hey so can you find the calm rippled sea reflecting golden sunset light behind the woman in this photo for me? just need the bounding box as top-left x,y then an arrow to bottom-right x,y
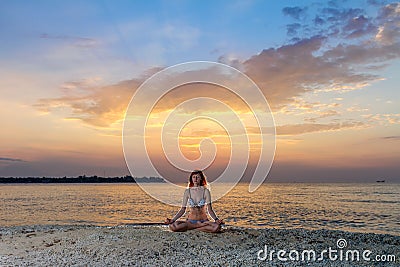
0,183 -> 400,235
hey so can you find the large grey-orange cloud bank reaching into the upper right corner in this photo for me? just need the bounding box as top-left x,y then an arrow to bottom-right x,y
243,4 -> 400,103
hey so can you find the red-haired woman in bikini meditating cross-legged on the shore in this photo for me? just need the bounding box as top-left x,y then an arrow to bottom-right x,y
165,170 -> 224,233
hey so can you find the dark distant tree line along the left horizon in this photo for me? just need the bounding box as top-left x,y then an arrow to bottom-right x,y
0,175 -> 165,184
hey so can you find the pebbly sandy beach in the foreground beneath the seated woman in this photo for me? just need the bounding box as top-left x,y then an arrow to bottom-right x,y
0,225 -> 400,266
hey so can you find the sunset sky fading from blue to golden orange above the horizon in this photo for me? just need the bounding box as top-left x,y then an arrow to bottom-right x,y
0,0 -> 400,182
